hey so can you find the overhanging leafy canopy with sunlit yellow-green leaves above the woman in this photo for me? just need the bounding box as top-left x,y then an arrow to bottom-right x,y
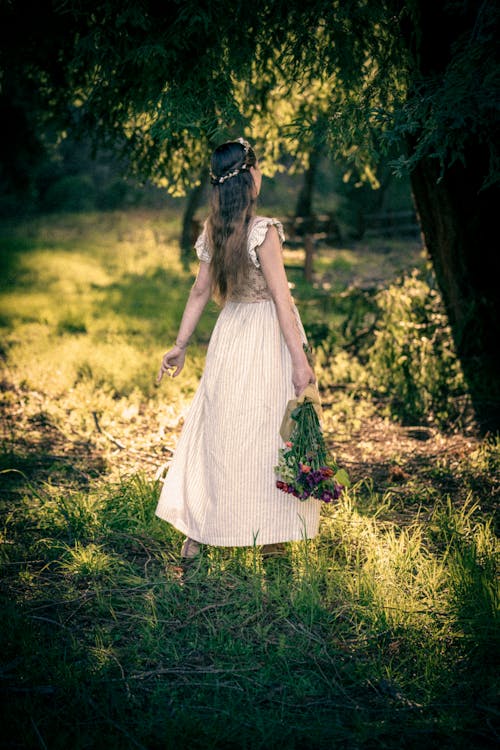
0,0 -> 498,191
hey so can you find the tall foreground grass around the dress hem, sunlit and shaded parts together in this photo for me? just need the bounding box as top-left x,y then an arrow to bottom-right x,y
1,476 -> 498,748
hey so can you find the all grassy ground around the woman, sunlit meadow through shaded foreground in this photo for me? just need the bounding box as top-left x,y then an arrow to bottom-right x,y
0,213 -> 500,750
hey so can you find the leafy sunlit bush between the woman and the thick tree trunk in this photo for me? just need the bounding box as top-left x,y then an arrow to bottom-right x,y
292,254 -> 471,429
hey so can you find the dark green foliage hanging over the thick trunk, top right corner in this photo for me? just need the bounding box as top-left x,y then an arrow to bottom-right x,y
386,0 -> 500,189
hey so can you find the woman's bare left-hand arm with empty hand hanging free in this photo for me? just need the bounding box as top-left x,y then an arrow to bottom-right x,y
156,261 -> 212,384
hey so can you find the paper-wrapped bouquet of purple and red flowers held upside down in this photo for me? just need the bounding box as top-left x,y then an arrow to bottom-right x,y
275,387 -> 349,503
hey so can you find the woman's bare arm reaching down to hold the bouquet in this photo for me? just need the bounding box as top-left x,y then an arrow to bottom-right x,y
258,226 -> 316,396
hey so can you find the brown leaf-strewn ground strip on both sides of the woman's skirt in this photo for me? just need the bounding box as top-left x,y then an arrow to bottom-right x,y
0,381 -> 500,523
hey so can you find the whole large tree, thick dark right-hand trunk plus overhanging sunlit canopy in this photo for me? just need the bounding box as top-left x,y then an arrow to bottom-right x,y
0,0 -> 500,429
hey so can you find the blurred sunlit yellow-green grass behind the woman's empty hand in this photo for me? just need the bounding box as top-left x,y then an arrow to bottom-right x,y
0,209 -> 214,406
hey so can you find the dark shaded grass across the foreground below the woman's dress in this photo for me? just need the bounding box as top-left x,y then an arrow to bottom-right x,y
0,536 -> 494,750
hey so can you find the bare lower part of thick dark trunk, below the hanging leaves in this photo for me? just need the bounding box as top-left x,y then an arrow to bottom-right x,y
411,144 -> 500,432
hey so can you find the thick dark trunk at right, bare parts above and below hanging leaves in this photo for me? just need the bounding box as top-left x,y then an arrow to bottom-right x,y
401,0 -> 500,432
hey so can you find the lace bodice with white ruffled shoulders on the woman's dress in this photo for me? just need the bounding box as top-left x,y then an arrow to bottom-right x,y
195,216 -> 285,302
